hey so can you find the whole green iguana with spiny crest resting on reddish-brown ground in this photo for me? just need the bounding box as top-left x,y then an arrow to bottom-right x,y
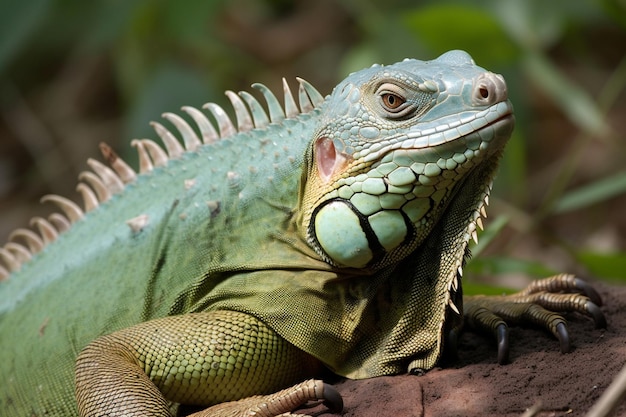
0,51 -> 604,416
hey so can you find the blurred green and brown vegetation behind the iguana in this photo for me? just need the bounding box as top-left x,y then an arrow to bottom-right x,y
0,0 -> 626,287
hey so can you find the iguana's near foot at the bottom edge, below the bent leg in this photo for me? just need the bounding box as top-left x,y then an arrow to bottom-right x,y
189,379 -> 343,417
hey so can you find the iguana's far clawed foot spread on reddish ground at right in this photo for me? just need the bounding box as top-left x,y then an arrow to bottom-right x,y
464,274 -> 606,364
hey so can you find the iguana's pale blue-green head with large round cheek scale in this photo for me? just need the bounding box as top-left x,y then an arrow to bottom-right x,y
300,51 -> 514,268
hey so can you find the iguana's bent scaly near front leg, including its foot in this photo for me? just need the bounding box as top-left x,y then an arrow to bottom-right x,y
76,311 -> 341,417
